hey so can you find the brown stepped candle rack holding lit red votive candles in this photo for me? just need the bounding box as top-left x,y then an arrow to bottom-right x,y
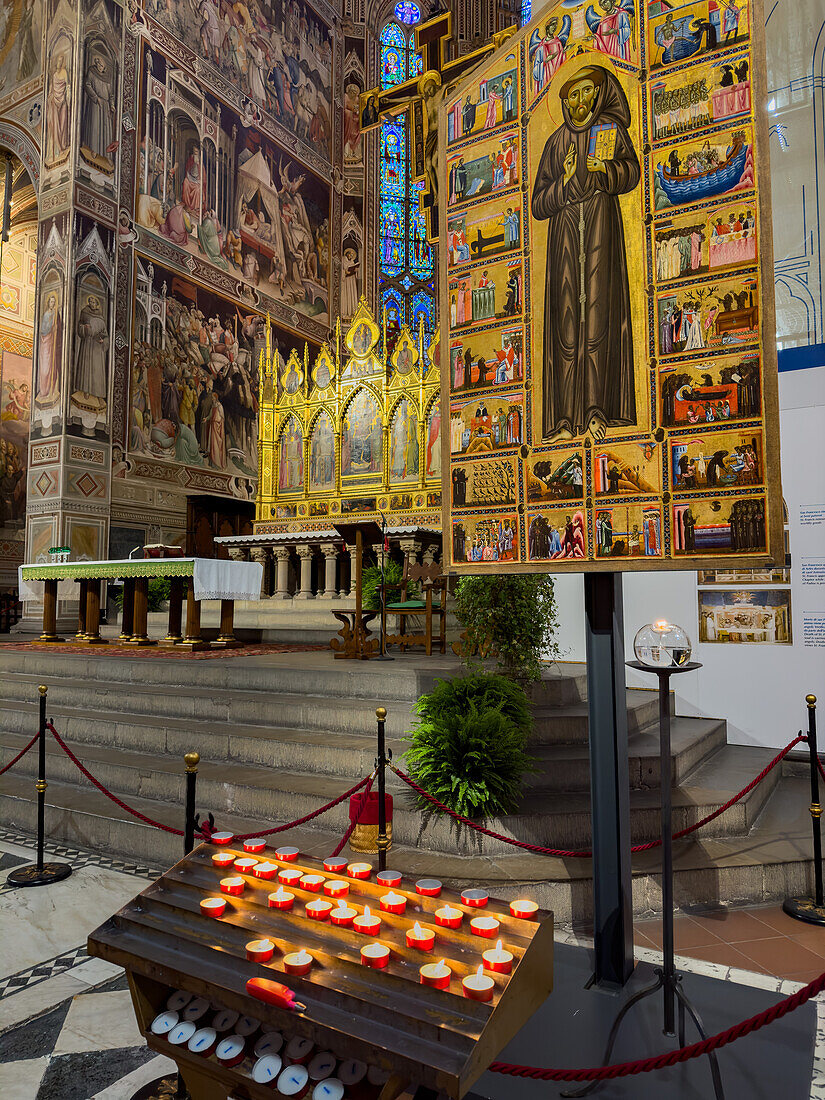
88,842 -> 553,1100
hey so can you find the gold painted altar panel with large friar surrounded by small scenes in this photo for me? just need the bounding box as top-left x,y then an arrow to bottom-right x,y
439,0 -> 782,572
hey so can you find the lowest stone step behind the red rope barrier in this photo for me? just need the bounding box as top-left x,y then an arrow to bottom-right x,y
0,772 -> 813,923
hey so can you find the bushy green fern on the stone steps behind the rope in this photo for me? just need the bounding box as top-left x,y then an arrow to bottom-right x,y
406,671 -> 534,817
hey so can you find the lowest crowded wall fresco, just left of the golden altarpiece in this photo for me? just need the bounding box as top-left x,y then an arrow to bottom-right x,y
129,260 -> 269,477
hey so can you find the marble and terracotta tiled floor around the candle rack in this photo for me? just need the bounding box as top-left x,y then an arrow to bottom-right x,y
0,828 -> 825,1100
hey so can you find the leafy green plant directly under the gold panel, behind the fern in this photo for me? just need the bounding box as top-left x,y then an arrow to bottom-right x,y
455,573 -> 558,683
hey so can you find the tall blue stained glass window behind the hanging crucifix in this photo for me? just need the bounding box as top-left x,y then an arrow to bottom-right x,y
378,19 -> 436,342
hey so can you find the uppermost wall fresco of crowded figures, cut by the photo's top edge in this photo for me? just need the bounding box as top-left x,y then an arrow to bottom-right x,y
152,0 -> 332,157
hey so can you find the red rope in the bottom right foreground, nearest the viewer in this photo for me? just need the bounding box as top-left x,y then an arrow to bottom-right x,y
490,972 -> 825,1081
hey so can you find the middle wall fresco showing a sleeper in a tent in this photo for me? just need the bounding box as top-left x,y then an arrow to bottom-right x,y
136,54 -> 330,322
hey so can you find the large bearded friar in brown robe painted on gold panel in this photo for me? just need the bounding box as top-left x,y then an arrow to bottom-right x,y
531,66 -> 640,439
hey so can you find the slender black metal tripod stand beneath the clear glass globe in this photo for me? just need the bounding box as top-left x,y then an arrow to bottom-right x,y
562,661 -> 725,1100
